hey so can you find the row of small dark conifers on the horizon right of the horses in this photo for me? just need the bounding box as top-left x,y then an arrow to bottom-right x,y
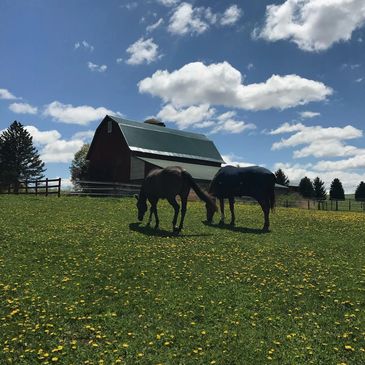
275,169 -> 365,201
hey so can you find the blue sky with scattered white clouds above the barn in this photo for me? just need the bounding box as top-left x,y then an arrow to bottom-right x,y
0,0 -> 365,193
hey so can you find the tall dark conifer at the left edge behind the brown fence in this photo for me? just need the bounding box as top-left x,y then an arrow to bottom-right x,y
0,121 -> 45,192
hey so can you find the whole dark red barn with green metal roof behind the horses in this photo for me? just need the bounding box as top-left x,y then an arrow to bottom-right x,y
87,115 -> 224,183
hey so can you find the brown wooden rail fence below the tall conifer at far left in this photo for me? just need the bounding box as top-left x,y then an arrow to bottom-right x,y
2,178 -> 61,197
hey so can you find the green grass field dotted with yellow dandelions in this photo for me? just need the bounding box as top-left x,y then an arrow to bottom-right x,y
0,195 -> 365,365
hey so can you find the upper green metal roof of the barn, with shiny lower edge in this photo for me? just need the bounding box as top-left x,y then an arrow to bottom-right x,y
108,116 -> 224,163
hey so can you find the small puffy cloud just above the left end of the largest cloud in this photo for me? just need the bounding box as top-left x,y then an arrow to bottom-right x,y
126,38 -> 160,65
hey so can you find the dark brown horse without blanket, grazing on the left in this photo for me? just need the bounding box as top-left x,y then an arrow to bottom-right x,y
136,166 -> 217,232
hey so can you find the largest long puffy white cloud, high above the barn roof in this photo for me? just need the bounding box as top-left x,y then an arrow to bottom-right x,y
138,62 -> 332,110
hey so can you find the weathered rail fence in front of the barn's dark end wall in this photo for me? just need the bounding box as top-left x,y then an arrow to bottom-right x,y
69,181 -> 141,197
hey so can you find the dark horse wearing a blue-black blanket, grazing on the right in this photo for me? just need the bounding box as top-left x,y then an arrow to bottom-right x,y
206,166 -> 276,231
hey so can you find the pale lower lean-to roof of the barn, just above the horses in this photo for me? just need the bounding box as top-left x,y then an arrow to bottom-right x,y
138,157 -> 220,180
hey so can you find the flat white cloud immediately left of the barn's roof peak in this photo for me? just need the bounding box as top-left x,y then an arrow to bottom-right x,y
43,101 -> 121,125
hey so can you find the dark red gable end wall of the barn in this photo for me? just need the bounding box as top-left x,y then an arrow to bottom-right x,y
89,118 -> 130,182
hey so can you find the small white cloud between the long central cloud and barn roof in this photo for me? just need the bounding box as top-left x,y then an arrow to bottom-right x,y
157,104 -> 215,129
